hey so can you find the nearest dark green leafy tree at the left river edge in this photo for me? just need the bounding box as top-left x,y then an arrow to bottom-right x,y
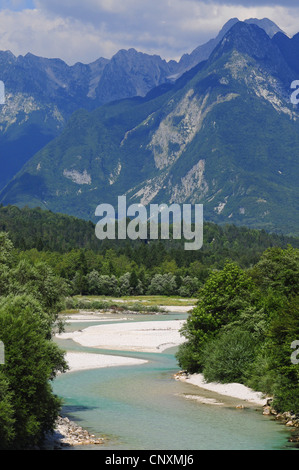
0,295 -> 67,448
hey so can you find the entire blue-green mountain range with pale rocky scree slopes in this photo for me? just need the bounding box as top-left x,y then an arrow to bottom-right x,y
0,19 -> 299,235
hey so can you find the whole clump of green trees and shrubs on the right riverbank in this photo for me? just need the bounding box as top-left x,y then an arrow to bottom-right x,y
177,247 -> 299,414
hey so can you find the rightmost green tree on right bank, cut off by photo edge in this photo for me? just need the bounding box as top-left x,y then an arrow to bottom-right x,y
248,246 -> 299,412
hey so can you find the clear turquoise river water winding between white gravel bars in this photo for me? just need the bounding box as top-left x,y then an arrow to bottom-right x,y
53,315 -> 294,450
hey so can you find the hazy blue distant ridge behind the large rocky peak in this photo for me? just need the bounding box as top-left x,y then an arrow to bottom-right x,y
0,18 -> 280,190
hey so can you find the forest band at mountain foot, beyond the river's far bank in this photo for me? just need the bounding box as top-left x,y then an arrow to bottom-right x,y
0,206 -> 299,296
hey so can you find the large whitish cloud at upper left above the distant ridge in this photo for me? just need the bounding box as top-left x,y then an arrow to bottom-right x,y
0,10 -> 119,63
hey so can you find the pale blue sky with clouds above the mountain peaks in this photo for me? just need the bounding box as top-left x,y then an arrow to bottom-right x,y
0,0 -> 299,64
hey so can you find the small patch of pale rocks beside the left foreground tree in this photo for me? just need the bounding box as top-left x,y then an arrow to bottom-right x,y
39,416 -> 105,450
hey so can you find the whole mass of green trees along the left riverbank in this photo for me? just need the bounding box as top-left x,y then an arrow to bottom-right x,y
0,233 -> 67,449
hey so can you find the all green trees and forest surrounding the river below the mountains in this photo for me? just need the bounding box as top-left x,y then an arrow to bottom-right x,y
0,207 -> 299,449
